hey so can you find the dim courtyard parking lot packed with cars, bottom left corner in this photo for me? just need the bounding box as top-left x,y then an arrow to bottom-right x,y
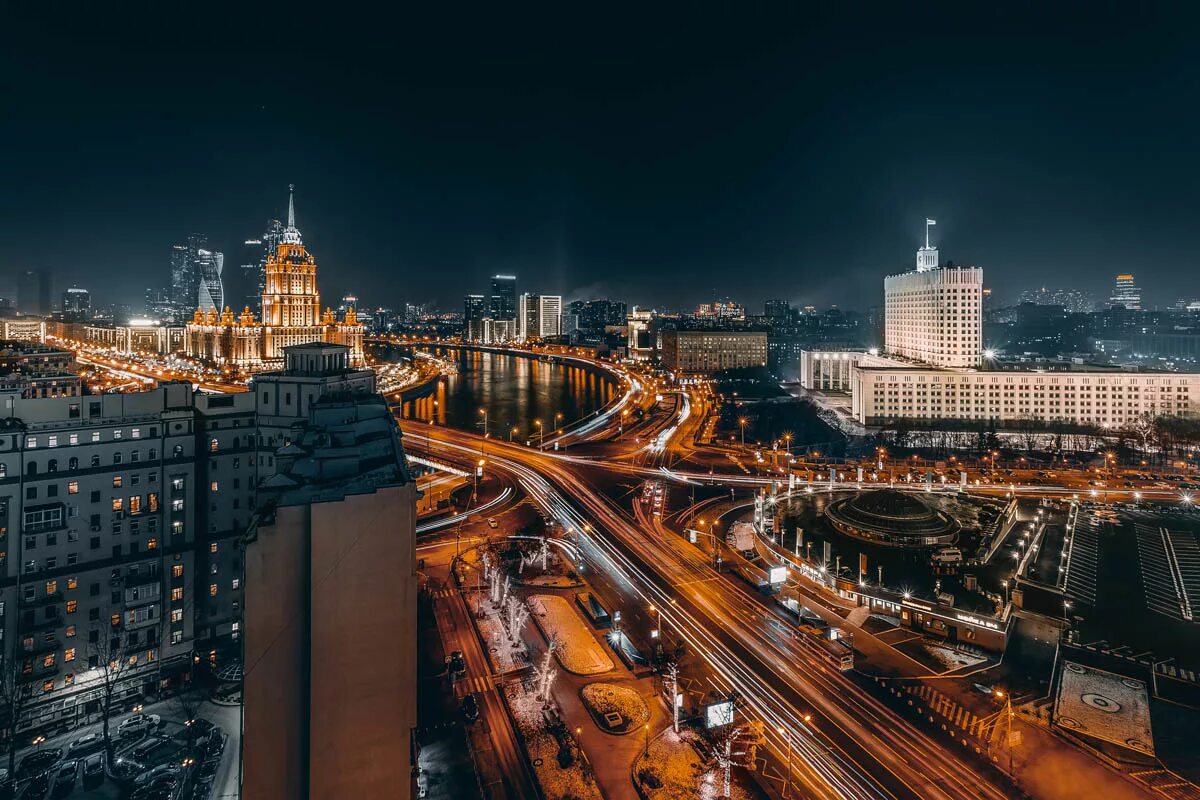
0,700 -> 240,800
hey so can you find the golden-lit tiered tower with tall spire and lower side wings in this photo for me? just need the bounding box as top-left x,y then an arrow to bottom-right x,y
186,193 -> 364,367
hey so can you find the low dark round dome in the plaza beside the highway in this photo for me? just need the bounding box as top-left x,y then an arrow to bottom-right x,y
824,489 -> 960,547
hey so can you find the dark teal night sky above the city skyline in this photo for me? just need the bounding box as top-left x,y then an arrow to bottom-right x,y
0,2 -> 1200,311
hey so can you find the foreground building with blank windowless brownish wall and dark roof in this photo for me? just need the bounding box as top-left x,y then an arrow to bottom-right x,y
242,345 -> 416,800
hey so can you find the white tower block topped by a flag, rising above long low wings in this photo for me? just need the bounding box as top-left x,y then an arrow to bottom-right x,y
883,223 -> 983,367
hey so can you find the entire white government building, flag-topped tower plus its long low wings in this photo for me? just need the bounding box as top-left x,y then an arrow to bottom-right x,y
800,221 -> 1200,428
